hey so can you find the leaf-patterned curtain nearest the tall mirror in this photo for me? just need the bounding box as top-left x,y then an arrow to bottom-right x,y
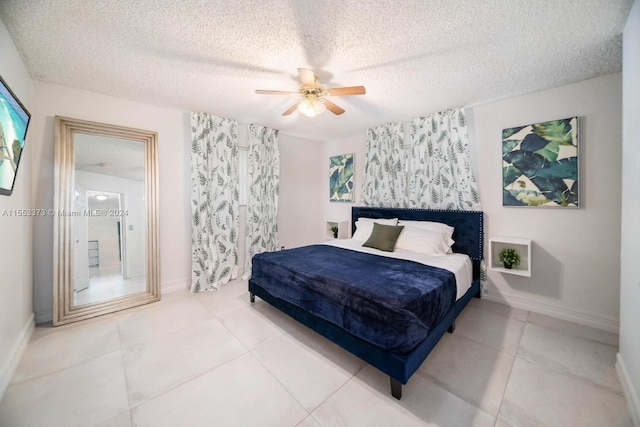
191,113 -> 239,292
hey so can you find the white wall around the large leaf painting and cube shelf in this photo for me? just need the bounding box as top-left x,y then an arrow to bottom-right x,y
471,73 -> 622,332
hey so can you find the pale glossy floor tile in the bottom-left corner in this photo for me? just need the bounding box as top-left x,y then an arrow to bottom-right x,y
0,351 -> 129,427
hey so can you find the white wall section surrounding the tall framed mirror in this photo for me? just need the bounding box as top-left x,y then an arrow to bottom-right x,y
30,82 -> 191,322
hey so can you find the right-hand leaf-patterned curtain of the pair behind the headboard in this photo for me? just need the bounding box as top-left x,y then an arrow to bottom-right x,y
408,108 -> 481,211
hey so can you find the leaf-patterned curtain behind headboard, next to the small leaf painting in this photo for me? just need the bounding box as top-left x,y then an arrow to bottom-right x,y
362,122 -> 407,208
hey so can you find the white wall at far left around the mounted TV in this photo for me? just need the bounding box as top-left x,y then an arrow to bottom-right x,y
0,21 -> 35,399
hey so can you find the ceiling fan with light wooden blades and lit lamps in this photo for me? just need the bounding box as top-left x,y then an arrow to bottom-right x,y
256,68 -> 366,117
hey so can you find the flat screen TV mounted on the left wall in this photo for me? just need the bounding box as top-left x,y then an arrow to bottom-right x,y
0,76 -> 31,196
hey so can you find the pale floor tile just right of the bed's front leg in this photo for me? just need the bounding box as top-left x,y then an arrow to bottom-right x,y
420,333 -> 514,416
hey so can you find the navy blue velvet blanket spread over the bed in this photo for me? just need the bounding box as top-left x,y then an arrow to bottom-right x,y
251,245 -> 456,354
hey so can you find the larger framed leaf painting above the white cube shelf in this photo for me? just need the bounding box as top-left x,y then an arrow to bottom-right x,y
502,117 -> 580,207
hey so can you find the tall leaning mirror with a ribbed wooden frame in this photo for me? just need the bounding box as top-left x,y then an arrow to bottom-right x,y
53,117 -> 160,326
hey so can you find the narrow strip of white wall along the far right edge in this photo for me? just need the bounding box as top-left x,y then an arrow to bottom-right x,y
618,0 -> 640,425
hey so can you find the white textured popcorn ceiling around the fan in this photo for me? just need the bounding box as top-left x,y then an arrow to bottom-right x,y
0,0 -> 633,141
